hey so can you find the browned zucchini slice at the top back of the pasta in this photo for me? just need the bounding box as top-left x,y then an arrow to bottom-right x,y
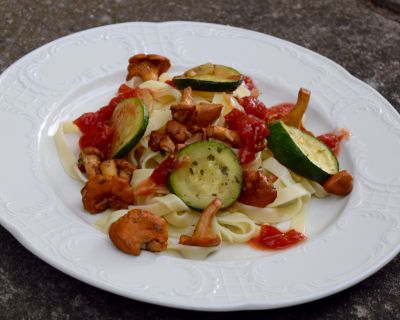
172,63 -> 243,92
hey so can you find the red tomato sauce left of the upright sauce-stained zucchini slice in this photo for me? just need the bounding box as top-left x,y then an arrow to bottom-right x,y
74,84 -> 137,158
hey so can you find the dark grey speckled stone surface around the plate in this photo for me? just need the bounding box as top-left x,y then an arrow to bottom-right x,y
0,0 -> 400,320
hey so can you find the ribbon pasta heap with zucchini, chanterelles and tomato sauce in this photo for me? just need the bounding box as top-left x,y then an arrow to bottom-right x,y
55,54 -> 353,259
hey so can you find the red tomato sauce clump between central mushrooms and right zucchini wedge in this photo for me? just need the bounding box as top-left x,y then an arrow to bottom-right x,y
225,109 -> 269,164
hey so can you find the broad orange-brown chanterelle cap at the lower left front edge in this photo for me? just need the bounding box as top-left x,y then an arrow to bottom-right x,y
109,209 -> 168,256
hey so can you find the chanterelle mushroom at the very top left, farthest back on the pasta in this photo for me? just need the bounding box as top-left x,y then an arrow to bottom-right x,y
126,53 -> 171,81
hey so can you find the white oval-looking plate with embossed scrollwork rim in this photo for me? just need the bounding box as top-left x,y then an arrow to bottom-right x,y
0,22 -> 400,310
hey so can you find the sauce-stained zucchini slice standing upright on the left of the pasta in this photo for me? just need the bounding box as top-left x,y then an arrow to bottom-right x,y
111,98 -> 149,158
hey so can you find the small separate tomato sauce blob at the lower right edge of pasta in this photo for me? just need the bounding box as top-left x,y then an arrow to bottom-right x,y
248,224 -> 307,250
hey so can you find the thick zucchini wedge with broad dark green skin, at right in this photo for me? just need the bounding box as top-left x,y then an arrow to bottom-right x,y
267,121 -> 339,182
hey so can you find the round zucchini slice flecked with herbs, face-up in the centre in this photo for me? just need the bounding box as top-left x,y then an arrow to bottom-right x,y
168,140 -> 243,210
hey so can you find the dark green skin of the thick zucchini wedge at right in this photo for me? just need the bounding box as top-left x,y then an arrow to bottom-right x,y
267,121 -> 339,182
